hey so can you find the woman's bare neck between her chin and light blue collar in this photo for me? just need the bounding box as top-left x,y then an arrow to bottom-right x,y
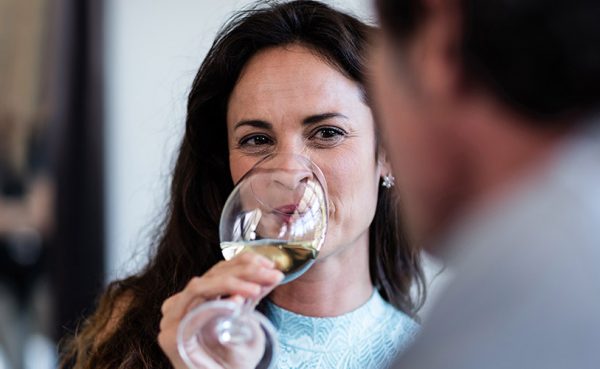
270,232 -> 373,317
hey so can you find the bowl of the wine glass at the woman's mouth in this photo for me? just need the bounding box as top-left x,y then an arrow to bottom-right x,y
219,154 -> 328,283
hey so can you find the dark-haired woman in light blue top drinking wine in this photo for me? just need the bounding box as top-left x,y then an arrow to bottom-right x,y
64,1 -> 424,368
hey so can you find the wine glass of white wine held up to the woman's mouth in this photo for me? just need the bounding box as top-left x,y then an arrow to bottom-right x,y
177,153 -> 328,369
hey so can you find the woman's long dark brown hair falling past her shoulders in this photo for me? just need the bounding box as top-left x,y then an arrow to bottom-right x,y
63,1 -> 425,368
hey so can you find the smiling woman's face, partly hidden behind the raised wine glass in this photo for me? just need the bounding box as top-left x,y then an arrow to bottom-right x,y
227,45 -> 387,258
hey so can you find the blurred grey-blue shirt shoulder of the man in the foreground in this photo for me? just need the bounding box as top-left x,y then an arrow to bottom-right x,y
396,127 -> 600,369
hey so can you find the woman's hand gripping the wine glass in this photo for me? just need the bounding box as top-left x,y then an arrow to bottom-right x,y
158,252 -> 283,369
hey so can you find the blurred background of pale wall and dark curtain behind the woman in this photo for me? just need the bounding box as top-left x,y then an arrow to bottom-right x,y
0,0 -> 384,369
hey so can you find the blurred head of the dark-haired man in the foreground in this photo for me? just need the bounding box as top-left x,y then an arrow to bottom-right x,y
373,0 -> 600,247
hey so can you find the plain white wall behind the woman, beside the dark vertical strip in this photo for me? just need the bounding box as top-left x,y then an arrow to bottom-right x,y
105,0 -> 372,280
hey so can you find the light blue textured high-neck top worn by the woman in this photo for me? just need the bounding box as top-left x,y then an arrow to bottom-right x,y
266,292 -> 419,369
